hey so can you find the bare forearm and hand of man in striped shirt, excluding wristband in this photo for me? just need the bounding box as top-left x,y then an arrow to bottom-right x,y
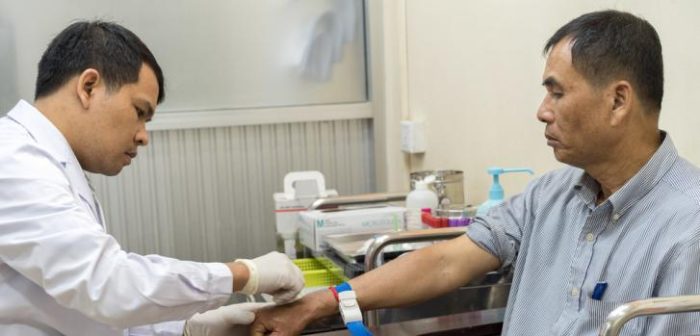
252,235 -> 500,335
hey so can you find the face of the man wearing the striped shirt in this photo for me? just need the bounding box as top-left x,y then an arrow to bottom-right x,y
537,39 -> 610,169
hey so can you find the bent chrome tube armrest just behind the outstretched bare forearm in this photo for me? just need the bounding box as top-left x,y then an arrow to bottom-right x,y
365,227 -> 466,327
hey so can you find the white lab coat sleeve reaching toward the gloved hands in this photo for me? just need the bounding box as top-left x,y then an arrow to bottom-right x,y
0,145 -> 232,329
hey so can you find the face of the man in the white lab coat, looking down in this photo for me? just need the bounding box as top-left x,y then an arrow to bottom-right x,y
78,65 -> 159,175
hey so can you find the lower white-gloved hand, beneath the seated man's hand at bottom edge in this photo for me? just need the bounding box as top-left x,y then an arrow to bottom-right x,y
184,302 -> 274,336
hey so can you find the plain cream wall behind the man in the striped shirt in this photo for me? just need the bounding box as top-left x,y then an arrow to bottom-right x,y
380,0 -> 700,204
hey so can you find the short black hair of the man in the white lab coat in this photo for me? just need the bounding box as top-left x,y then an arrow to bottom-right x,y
34,21 -> 165,103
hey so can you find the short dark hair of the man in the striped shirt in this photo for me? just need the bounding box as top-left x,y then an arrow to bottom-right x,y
544,10 -> 664,111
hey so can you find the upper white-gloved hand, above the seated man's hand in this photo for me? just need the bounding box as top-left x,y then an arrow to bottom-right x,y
236,252 -> 304,303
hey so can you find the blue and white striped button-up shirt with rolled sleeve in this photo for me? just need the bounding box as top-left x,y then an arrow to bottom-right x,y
468,134 -> 700,336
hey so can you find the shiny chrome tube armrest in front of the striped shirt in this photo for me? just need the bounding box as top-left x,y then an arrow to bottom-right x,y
598,295 -> 700,336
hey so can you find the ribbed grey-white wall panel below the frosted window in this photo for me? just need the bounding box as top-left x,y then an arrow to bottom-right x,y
91,119 -> 374,261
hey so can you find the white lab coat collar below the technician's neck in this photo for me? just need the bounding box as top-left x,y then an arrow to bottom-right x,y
7,100 -> 104,224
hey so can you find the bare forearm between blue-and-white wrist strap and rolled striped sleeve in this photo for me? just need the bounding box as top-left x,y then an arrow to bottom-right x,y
350,236 -> 499,310
